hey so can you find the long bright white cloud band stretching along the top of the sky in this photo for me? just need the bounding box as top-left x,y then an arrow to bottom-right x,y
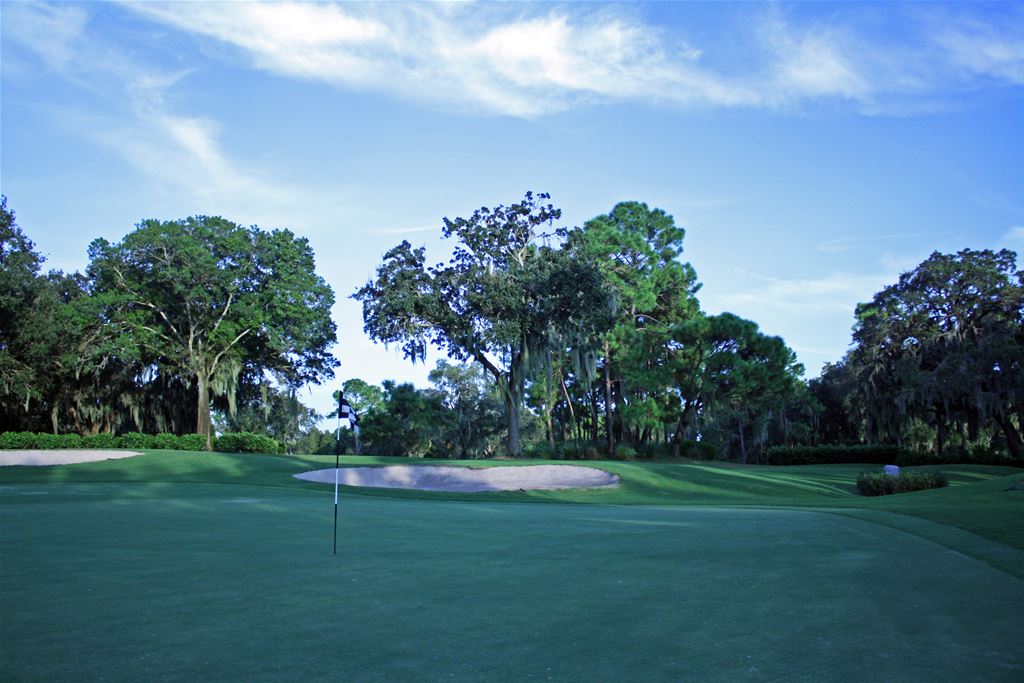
125,2 -> 1024,117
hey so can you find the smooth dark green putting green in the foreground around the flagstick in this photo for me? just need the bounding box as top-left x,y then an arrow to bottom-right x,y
0,482 -> 1024,681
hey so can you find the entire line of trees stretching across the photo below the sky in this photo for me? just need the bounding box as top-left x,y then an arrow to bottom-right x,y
0,193 -> 1024,462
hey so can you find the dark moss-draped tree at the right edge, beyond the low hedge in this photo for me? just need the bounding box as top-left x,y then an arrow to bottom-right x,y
849,249 -> 1024,458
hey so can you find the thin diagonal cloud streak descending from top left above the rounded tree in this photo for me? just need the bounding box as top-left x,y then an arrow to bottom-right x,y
4,3 -> 301,225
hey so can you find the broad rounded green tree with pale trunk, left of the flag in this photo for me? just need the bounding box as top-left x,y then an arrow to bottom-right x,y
88,216 -> 337,443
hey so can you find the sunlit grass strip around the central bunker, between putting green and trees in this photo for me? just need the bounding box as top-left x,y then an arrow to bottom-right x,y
0,451 -> 1024,552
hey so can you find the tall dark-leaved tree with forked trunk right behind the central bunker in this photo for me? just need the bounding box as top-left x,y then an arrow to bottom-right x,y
353,193 -> 607,456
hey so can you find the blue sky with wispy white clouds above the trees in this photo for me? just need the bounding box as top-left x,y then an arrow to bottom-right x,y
0,2 -> 1024,421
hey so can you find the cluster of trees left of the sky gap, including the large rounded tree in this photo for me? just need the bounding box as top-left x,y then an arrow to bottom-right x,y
0,198 -> 337,442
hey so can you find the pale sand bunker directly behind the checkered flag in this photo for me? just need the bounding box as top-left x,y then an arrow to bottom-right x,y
292,465 -> 618,493
